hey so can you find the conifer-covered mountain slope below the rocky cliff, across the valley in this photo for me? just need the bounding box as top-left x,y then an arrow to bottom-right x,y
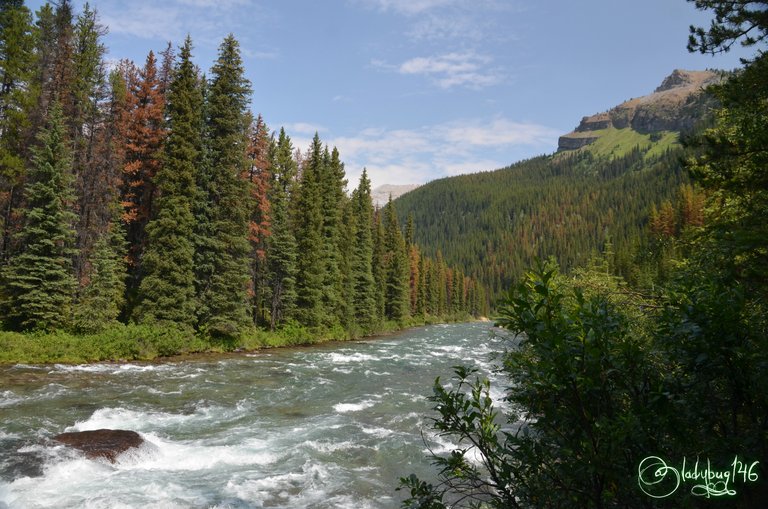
396,97 -> 707,302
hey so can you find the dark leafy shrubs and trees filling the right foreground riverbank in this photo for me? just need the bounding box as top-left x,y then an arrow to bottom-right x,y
401,0 -> 768,509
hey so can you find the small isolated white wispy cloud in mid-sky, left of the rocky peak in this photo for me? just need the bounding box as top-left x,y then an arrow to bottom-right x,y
378,51 -> 503,89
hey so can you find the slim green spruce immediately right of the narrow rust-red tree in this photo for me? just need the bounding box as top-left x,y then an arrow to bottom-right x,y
266,129 -> 297,330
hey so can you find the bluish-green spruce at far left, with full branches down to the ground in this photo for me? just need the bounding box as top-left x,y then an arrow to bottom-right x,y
3,103 -> 76,329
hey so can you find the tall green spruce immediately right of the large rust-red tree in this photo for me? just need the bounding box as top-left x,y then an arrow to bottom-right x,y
134,38 -> 203,327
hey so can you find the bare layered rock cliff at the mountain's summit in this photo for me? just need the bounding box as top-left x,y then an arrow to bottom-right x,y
558,69 -> 722,151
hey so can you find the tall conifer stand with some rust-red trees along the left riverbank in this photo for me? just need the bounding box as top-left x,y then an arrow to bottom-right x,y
0,0 -> 486,358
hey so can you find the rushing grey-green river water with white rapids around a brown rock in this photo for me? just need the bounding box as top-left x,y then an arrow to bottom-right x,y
0,323 -> 502,509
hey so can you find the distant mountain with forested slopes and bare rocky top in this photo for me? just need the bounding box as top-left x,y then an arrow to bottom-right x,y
396,70 -> 721,304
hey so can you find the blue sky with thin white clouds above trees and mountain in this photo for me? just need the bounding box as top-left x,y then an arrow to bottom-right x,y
27,0 -> 751,188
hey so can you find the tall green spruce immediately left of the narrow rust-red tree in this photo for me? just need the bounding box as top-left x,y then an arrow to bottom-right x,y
200,34 -> 251,336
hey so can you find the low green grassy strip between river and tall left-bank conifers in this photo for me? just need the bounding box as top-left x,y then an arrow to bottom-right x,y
0,315 -> 470,364
